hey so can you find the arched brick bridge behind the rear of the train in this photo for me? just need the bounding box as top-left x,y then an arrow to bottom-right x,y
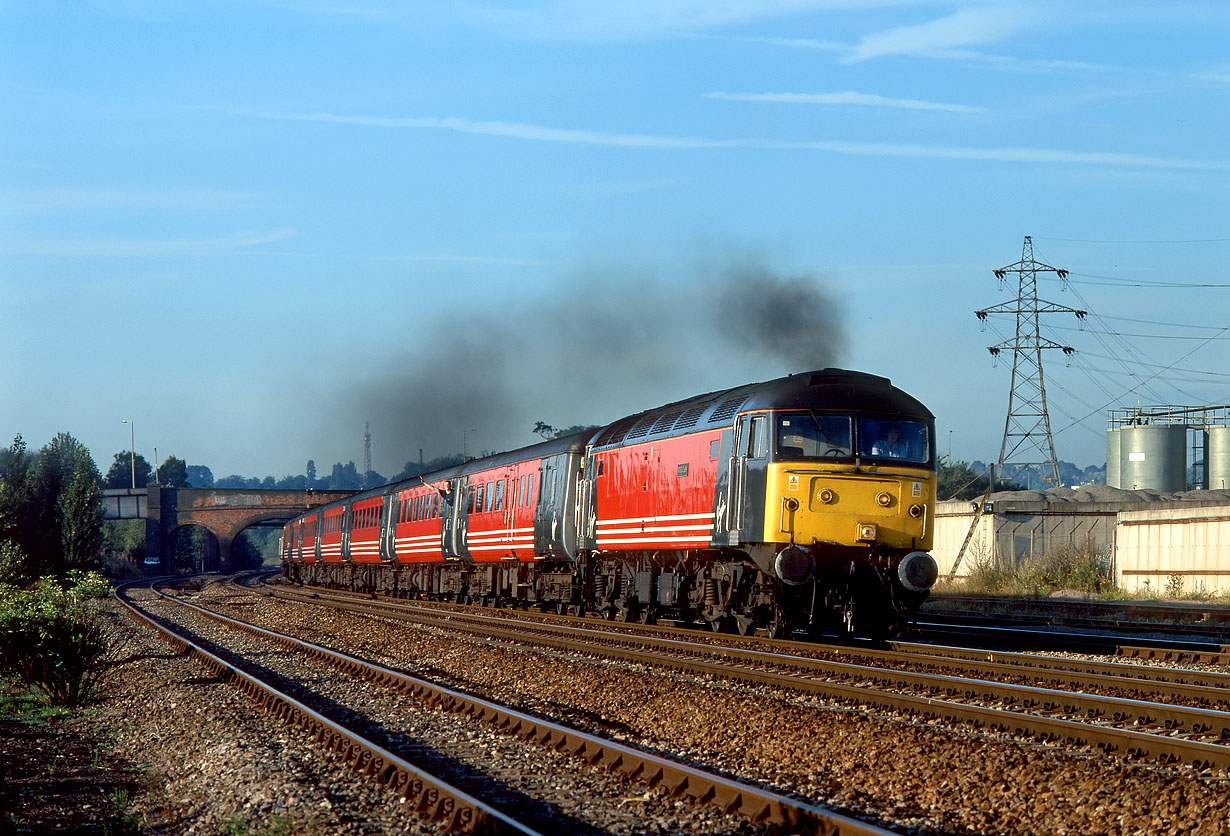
144,487 -> 353,572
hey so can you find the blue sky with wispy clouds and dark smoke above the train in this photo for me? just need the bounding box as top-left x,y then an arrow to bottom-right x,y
0,0 -> 1230,477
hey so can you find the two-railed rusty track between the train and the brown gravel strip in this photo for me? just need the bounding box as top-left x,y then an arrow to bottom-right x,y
269,589 -> 1230,768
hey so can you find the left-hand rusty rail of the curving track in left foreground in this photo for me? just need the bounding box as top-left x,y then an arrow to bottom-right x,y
114,582 -> 541,836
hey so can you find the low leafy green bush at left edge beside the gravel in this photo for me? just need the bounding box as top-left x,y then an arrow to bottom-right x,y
0,572 -> 111,706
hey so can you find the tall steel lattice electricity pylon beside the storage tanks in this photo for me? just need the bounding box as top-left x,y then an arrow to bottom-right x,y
974,235 -> 1086,487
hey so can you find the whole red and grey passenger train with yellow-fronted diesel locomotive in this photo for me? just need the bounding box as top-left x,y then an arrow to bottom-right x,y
280,369 -> 937,637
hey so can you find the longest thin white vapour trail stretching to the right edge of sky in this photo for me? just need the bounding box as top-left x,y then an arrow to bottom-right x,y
257,113 -> 1230,171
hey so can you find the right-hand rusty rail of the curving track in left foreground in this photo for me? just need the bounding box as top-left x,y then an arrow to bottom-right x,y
158,580 -> 893,836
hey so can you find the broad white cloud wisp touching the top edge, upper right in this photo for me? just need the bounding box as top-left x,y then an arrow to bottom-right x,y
849,5 -> 1030,61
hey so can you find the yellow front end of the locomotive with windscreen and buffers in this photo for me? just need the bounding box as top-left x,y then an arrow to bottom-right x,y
742,409 -> 937,633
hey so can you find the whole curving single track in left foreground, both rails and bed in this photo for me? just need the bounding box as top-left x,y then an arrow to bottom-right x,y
115,577 -> 892,835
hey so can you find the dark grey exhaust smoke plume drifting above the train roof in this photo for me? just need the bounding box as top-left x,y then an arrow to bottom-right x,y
320,262 -> 846,477
